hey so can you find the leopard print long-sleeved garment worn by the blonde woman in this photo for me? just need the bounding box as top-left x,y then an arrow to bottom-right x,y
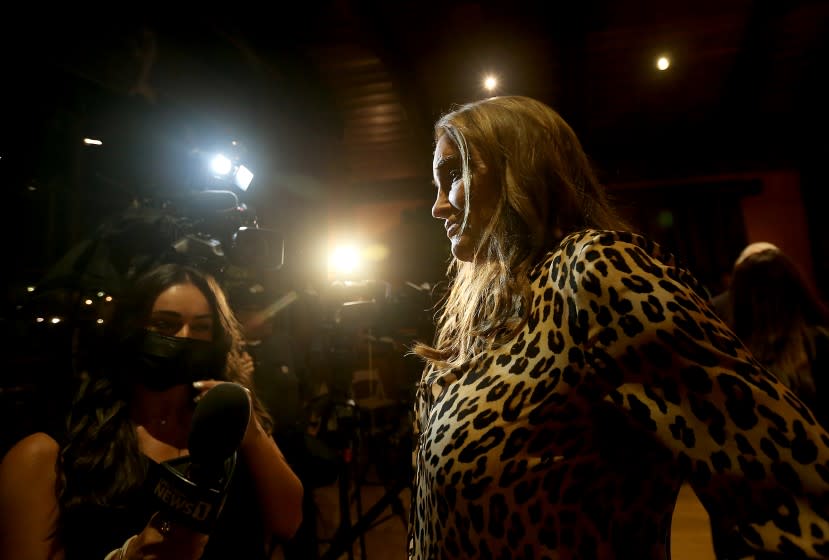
409,230 -> 829,560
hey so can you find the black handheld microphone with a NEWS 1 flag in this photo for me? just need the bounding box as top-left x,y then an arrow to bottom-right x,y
149,383 -> 251,534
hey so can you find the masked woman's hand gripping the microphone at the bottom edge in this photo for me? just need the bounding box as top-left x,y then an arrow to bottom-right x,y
121,512 -> 208,560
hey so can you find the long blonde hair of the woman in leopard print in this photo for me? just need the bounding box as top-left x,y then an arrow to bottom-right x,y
414,96 -> 627,368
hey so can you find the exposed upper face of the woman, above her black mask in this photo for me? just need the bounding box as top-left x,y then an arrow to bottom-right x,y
147,284 -> 214,341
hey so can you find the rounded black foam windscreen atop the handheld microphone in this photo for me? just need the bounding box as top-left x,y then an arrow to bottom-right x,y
187,383 -> 251,466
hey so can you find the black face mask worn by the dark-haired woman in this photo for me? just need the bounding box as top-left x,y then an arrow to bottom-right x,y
124,330 -> 225,391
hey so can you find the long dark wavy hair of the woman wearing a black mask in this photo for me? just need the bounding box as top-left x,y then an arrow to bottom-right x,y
58,264 -> 272,530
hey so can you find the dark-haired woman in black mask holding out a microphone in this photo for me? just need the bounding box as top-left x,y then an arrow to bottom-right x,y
0,264 -> 303,560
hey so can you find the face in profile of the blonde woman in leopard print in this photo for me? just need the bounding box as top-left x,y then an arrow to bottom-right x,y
432,134 -> 498,262
